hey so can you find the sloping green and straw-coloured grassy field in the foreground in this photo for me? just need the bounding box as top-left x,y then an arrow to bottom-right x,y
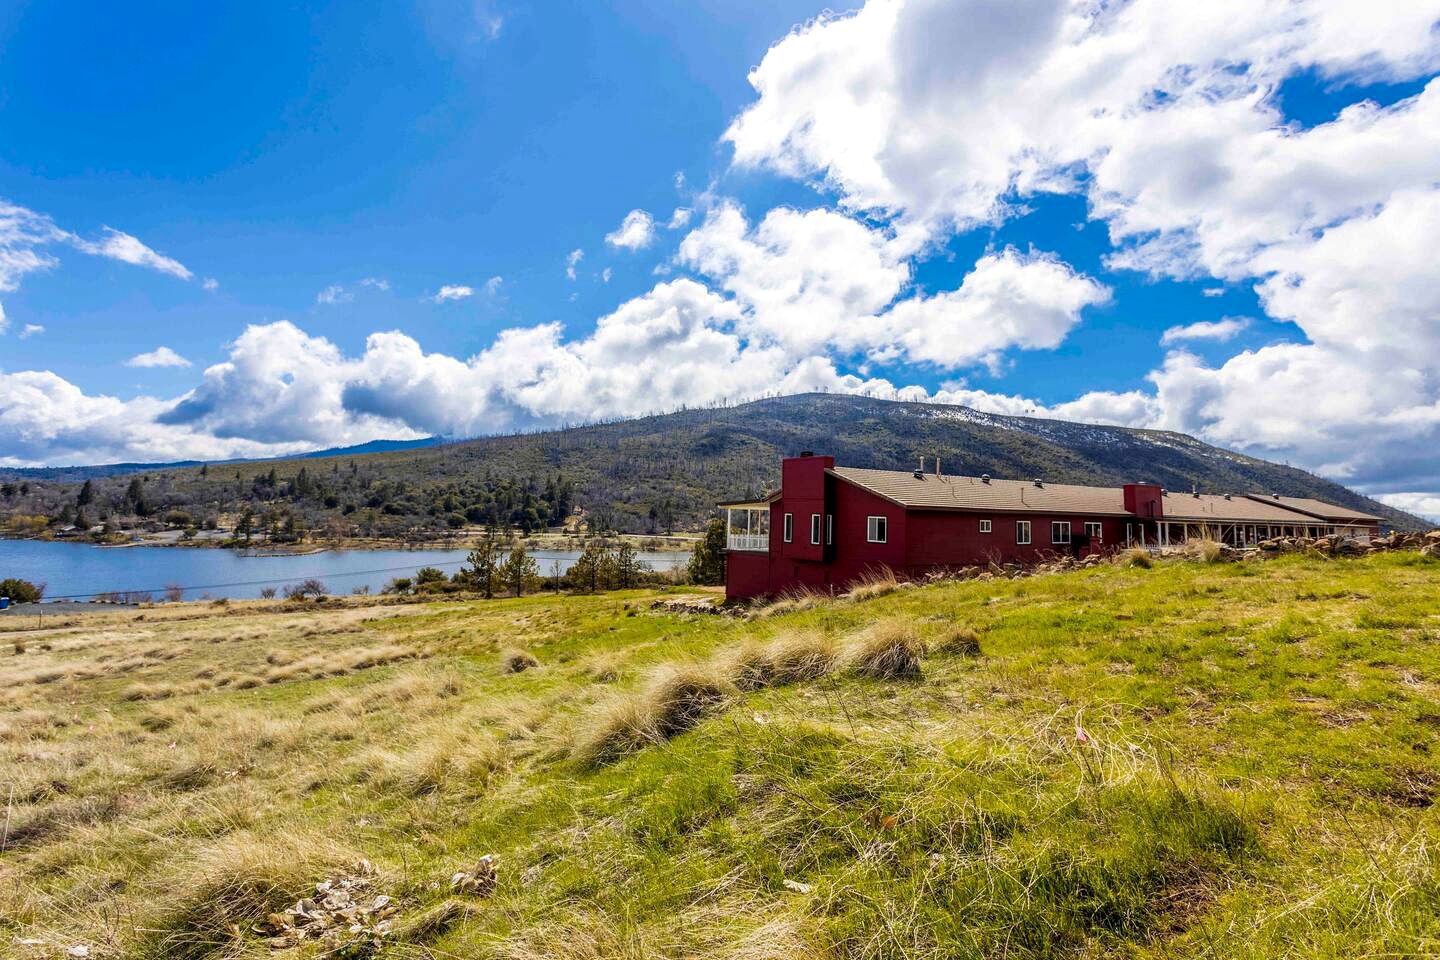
0,553 -> 1440,960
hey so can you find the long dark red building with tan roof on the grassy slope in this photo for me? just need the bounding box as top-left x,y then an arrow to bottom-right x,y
720,453 -> 1380,599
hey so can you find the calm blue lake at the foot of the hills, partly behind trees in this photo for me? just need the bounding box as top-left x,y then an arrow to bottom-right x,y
0,540 -> 690,600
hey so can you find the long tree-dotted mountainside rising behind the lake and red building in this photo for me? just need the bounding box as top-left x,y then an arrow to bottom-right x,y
0,394 -> 1421,540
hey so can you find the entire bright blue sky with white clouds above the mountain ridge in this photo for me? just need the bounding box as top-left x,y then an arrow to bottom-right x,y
0,0 -> 1440,511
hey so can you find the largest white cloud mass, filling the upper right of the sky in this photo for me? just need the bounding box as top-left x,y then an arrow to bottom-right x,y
726,0 -> 1440,489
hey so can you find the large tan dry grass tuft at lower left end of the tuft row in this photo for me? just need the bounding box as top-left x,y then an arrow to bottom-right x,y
570,664 -> 736,767
